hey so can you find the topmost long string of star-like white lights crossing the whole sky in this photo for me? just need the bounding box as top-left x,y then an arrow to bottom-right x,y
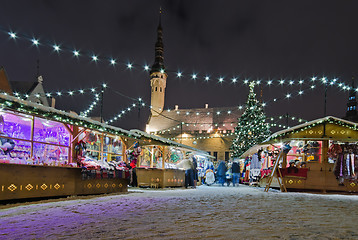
0,26 -> 358,94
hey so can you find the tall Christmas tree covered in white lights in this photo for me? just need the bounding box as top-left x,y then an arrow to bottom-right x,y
230,82 -> 271,157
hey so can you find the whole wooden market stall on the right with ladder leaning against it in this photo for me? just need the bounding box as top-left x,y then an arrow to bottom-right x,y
260,116 -> 358,192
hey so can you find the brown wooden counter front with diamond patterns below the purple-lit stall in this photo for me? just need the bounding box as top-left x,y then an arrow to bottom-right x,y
0,163 -> 128,200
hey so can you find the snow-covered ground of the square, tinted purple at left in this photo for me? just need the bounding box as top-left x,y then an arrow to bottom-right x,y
0,185 -> 358,240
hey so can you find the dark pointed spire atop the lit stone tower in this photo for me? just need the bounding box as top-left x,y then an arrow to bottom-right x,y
150,8 -> 165,73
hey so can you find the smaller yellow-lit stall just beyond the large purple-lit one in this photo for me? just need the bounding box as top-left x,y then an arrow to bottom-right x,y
131,130 -> 211,188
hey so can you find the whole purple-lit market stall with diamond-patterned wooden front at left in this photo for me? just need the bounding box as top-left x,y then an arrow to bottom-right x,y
0,94 -> 139,200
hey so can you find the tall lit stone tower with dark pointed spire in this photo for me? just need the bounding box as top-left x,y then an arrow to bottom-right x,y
150,9 -> 168,117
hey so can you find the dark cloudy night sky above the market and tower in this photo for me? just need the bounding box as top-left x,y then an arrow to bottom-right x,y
0,0 -> 358,129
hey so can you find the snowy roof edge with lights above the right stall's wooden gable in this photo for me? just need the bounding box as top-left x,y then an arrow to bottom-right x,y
263,116 -> 358,144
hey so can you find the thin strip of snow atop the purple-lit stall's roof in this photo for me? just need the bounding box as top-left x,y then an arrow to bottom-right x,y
0,93 -> 140,137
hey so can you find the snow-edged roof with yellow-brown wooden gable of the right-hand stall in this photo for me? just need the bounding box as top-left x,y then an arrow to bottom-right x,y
262,116 -> 358,144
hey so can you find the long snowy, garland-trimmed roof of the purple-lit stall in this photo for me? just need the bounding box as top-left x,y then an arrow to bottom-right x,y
0,93 -> 140,138
